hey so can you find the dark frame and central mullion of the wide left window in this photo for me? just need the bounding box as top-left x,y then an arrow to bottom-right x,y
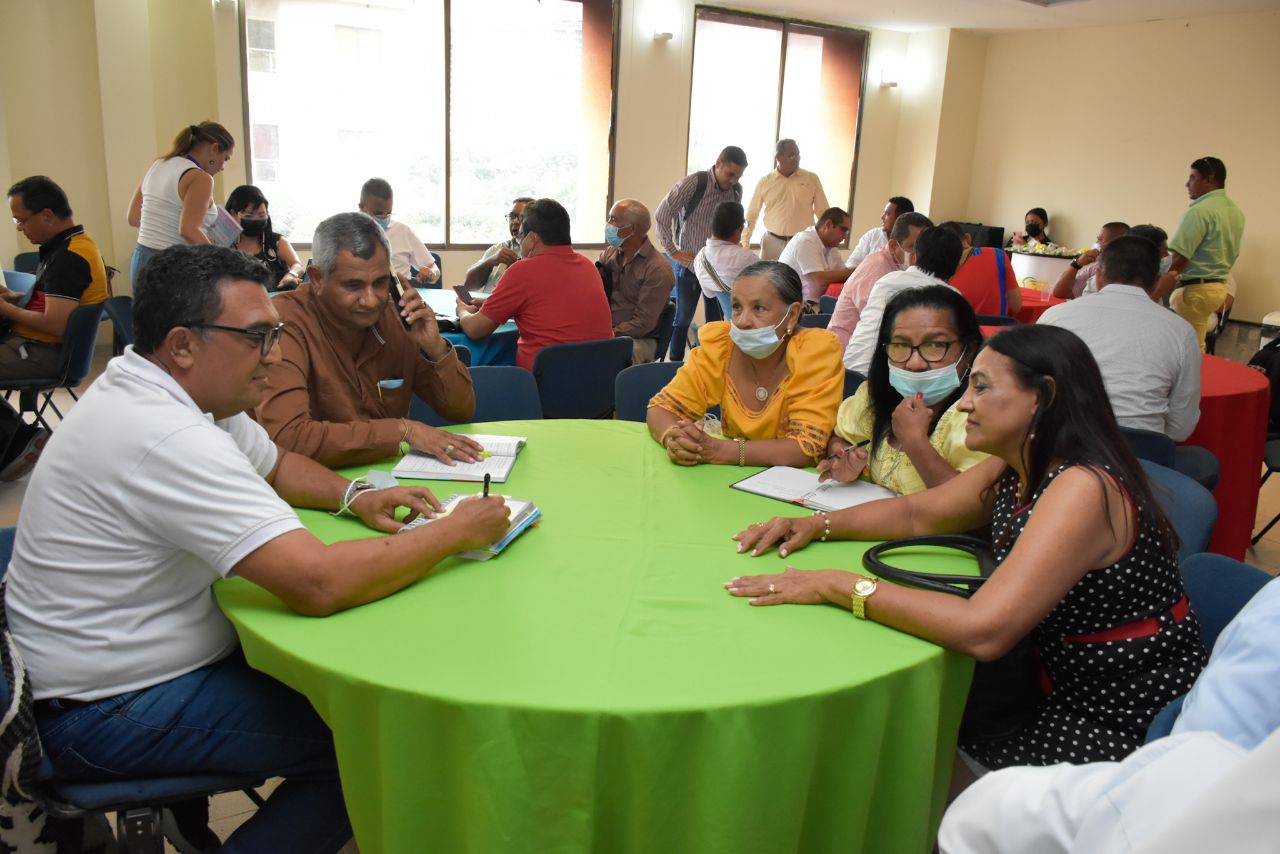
236,0 -> 624,252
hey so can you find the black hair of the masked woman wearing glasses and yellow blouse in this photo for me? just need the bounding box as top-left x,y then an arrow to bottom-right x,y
867,284 -> 982,453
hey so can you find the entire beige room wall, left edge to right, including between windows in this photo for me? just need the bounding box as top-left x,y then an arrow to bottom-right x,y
0,0 -> 1280,320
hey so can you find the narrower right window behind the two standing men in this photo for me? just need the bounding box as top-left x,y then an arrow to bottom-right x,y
689,8 -> 867,241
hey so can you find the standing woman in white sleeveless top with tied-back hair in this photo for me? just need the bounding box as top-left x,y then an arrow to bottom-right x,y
128,122 -> 236,283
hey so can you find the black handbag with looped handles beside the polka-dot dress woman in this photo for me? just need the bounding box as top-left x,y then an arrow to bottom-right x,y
863,534 -> 1043,741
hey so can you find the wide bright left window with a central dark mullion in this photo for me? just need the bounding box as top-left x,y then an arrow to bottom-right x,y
244,0 -> 613,248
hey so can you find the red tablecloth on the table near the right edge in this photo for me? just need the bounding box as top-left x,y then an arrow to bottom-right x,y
1185,355 -> 1271,561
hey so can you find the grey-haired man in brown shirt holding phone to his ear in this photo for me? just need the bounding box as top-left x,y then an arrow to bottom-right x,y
256,213 -> 481,467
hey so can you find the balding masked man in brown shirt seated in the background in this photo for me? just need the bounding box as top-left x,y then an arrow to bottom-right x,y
600,198 -> 676,364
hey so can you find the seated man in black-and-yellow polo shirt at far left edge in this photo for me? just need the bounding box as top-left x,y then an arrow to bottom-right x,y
0,175 -> 106,480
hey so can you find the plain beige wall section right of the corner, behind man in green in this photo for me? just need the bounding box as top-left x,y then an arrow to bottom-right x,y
968,13 -> 1280,321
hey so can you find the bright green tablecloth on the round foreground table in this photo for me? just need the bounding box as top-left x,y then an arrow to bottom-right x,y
216,421 -> 972,854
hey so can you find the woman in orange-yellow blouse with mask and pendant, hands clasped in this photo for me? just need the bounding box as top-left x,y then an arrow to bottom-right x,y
648,261 -> 845,467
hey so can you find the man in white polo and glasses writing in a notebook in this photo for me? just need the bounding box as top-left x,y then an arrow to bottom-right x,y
5,246 -> 507,851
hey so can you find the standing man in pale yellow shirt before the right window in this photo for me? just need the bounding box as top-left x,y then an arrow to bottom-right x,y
742,140 -> 828,261
